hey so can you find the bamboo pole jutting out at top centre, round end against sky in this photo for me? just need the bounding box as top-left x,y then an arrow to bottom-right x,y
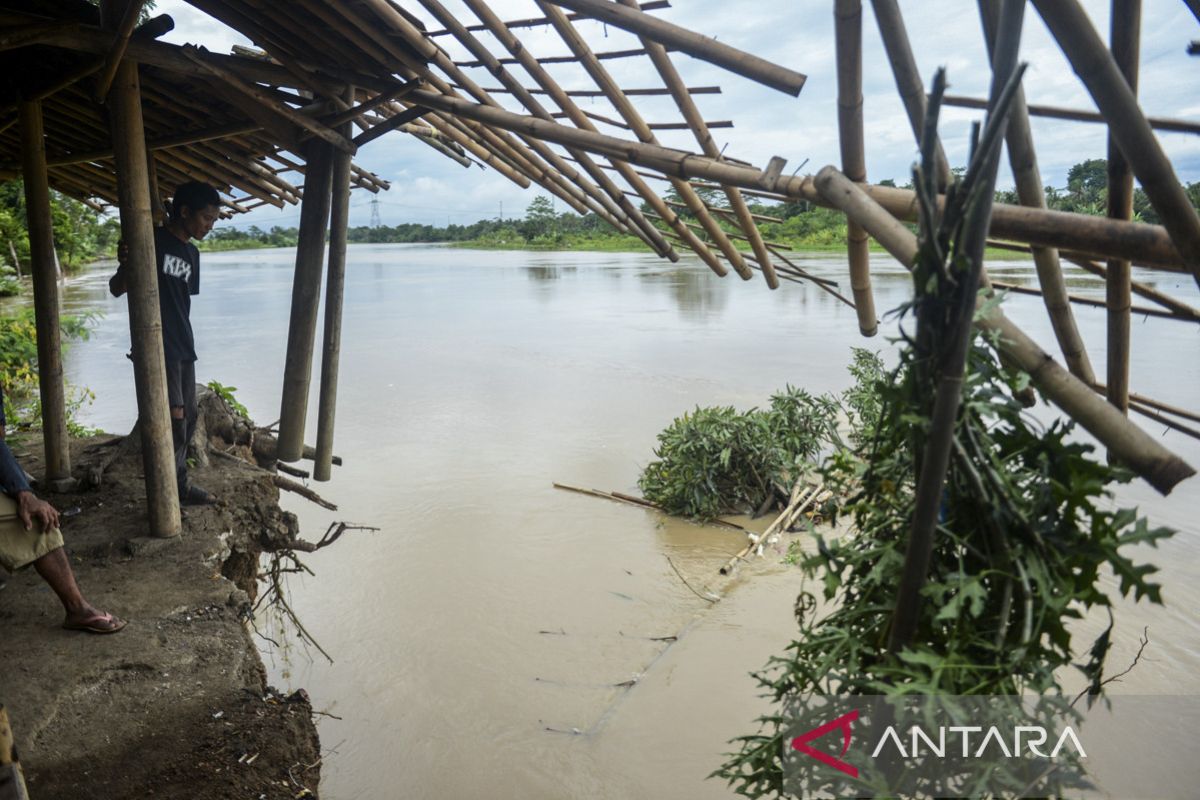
542,0 -> 805,97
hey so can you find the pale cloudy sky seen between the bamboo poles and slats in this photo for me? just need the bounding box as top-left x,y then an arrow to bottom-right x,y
156,0 -> 1200,228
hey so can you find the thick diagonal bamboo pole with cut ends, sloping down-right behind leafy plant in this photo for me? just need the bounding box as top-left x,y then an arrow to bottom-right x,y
820,167 -> 1195,494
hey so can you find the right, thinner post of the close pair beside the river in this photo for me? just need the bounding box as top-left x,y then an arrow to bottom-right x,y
312,86 -> 354,481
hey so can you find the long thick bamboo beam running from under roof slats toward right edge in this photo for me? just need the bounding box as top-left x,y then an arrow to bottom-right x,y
413,89 -> 1186,272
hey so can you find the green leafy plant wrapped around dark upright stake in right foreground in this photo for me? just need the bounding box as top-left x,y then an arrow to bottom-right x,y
715,80 -> 1172,798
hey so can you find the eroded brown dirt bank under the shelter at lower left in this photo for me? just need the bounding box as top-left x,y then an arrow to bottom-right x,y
0,398 -> 320,800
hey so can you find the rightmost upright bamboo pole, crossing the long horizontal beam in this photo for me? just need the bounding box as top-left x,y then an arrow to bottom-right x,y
1093,0 -> 1141,414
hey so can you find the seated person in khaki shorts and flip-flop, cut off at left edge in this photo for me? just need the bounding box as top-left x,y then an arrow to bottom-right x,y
0,441 -> 125,633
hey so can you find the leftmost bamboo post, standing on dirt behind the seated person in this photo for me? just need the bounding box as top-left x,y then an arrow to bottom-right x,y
19,101 -> 71,485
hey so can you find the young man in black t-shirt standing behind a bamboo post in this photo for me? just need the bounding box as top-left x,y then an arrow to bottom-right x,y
108,181 -> 221,505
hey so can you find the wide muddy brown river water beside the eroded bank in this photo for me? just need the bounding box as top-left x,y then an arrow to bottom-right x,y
58,245 -> 1200,800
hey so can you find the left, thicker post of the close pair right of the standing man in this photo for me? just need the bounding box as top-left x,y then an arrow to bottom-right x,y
278,139 -> 334,462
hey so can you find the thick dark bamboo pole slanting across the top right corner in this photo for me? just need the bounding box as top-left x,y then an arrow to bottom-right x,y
1033,0 -> 1200,284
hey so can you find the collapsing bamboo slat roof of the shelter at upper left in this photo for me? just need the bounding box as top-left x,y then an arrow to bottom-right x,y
0,0 -> 804,287
